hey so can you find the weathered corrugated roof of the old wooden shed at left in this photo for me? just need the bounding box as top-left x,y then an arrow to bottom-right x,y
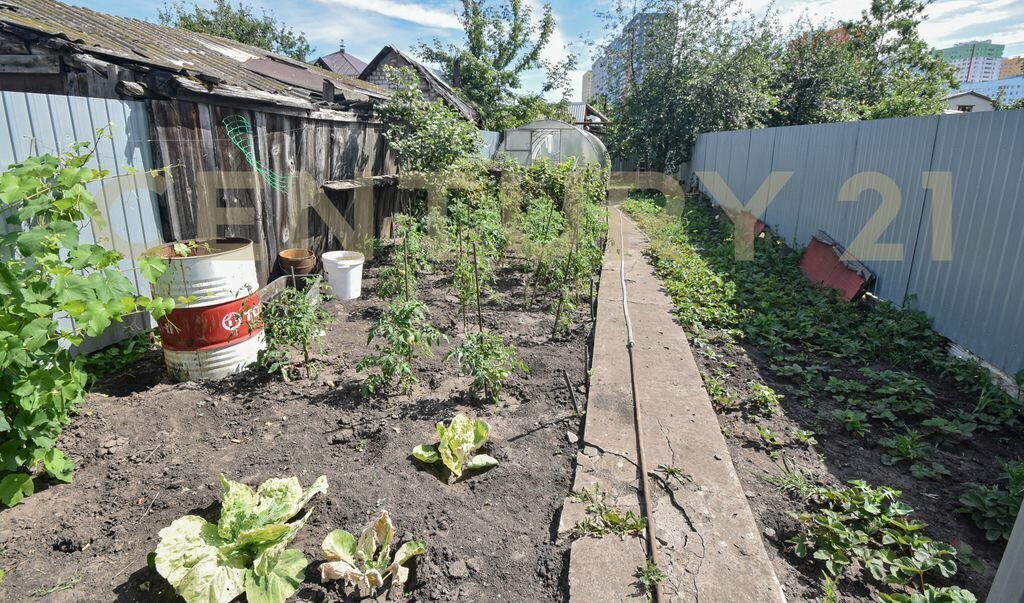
0,0 -> 386,100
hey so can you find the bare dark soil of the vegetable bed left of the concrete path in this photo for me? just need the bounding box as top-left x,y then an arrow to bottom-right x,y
0,262 -> 591,602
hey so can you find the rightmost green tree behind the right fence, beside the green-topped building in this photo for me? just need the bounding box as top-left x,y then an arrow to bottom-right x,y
843,0 -> 956,119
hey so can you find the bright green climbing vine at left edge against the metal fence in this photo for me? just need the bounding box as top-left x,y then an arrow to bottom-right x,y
0,140 -> 174,507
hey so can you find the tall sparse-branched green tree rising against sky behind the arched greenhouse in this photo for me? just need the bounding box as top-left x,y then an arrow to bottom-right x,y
418,0 -> 575,130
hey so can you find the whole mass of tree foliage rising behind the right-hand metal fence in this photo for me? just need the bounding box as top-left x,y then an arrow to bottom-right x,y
606,0 -> 954,169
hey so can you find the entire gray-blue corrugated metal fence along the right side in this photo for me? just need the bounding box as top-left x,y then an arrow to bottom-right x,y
693,111 -> 1024,375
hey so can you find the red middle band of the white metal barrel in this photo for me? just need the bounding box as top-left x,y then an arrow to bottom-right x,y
158,293 -> 263,351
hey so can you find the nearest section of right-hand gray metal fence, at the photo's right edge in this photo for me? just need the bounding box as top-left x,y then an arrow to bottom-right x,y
909,111 -> 1024,374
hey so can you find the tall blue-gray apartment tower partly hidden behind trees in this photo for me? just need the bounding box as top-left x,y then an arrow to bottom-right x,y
591,12 -> 674,103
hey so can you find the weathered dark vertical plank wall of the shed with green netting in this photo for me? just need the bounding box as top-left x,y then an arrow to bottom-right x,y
150,100 -> 400,282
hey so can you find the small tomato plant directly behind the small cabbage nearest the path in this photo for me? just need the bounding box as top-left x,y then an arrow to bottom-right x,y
444,331 -> 527,404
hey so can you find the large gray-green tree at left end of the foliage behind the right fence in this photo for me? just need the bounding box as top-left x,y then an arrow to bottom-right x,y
606,0 -> 777,170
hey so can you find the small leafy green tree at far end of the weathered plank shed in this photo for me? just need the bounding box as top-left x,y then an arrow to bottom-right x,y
375,67 -> 483,172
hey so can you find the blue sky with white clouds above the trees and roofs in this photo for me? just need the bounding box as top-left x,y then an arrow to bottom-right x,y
75,0 -> 1024,99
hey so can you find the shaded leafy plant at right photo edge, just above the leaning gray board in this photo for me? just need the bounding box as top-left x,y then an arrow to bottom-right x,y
956,461 -> 1024,541
